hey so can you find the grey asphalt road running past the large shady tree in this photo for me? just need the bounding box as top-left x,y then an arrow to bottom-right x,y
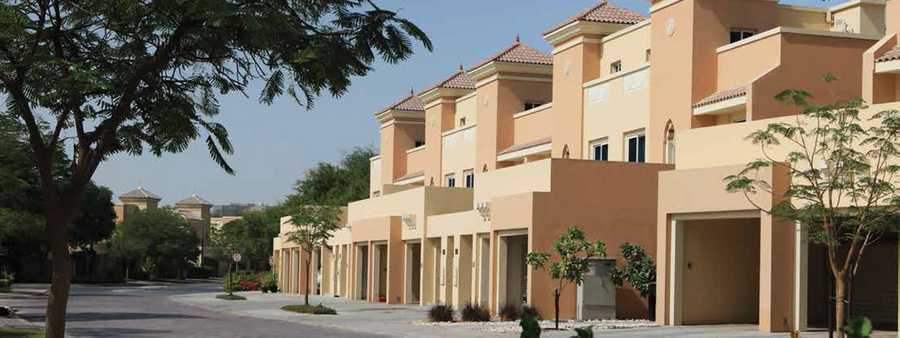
0,283 -> 382,337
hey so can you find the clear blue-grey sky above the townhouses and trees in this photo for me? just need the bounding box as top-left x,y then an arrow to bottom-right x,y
94,0 -> 843,204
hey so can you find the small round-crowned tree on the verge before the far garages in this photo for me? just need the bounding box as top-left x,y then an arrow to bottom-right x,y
288,205 -> 340,305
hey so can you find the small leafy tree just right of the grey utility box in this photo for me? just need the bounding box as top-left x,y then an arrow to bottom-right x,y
610,243 -> 656,319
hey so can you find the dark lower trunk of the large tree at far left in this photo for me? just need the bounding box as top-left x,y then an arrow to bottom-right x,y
45,214 -> 72,338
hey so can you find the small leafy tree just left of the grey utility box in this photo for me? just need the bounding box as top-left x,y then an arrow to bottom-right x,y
525,226 -> 606,329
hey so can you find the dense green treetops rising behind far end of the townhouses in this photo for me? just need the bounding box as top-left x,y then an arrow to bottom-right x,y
288,147 -> 376,206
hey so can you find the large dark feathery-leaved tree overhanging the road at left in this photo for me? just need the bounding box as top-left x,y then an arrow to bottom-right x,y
0,0 -> 431,337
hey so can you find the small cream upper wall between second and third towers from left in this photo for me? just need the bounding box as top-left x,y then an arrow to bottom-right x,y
440,123 -> 477,187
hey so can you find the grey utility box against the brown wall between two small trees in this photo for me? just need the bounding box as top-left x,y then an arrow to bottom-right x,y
576,259 -> 616,320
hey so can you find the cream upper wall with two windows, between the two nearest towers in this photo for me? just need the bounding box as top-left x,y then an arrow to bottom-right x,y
583,64 -> 651,161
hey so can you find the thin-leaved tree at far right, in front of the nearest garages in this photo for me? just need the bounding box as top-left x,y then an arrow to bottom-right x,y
725,76 -> 900,335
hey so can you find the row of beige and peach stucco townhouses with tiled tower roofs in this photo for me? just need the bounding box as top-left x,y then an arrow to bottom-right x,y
273,0 -> 900,331
